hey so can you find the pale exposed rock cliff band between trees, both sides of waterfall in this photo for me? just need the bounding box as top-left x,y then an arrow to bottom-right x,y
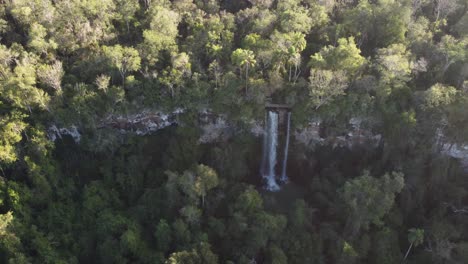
48,109 -> 468,172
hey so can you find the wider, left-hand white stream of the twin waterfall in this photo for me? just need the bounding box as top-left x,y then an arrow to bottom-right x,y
262,111 -> 279,191
